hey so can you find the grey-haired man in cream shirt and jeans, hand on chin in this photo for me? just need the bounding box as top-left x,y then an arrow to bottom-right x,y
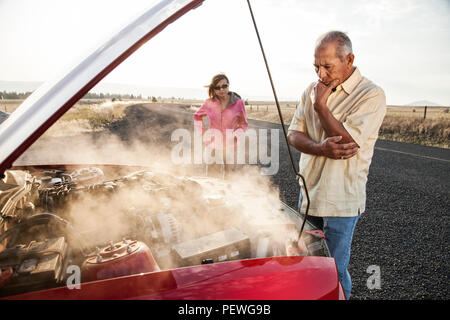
288,31 -> 386,299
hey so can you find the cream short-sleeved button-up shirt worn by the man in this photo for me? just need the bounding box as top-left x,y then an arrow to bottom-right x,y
289,68 -> 386,217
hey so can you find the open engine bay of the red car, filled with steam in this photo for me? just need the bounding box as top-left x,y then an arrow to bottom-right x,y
0,165 -> 329,296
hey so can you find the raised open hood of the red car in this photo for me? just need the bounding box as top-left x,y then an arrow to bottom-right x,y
0,0 -> 204,175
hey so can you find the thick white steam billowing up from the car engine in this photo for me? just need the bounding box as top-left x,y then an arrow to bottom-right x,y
11,127 -> 296,267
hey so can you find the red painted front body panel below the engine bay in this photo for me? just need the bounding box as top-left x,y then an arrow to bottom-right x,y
6,256 -> 345,300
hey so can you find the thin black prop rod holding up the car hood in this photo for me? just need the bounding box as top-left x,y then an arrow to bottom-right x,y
247,0 -> 310,240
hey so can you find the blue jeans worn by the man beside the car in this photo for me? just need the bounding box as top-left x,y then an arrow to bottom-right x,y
298,191 -> 360,299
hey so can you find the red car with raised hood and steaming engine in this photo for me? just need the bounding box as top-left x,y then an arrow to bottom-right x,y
0,0 -> 345,300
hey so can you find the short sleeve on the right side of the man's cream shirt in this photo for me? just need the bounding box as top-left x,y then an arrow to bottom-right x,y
343,87 -> 386,146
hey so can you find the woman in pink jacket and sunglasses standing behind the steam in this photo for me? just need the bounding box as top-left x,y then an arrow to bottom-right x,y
194,73 -> 248,177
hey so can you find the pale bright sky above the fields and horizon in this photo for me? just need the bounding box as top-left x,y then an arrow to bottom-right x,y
0,0 -> 450,106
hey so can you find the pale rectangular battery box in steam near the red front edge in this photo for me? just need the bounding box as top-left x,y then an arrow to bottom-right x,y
172,227 -> 250,267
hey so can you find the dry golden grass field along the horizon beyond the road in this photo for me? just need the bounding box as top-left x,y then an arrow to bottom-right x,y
0,99 -> 450,149
